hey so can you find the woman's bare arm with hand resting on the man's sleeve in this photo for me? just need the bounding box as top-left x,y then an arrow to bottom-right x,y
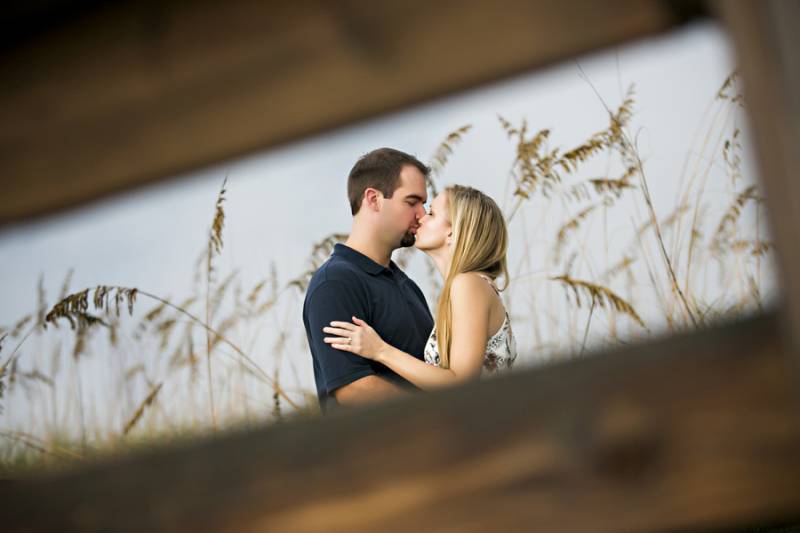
323,274 -> 495,390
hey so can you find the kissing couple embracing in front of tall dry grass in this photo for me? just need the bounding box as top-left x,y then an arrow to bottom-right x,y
303,148 -> 517,413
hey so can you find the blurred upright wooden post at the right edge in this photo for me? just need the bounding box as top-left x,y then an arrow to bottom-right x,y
716,0 -> 800,354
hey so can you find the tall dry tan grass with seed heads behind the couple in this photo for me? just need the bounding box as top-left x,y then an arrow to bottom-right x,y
0,68 -> 773,471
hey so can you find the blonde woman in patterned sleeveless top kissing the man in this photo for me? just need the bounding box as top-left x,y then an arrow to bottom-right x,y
323,185 -> 517,390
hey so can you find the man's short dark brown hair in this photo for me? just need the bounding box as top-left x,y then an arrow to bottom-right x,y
347,148 -> 431,215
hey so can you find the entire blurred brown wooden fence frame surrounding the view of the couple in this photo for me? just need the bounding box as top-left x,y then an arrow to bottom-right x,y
0,0 -> 800,531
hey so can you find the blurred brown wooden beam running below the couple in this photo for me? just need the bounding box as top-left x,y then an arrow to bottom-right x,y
0,314 -> 800,532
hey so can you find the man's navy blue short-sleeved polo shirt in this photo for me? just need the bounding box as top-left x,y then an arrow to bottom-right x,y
303,244 -> 433,412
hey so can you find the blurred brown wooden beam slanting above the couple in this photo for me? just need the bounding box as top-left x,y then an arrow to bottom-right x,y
0,0 -> 702,226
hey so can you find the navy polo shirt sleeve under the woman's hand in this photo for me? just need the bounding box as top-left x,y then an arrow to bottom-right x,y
306,281 -> 375,394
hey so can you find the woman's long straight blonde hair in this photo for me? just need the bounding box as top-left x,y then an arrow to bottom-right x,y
436,185 -> 508,368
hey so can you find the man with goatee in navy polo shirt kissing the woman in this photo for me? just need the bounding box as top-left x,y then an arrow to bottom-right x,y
303,148 -> 433,412
